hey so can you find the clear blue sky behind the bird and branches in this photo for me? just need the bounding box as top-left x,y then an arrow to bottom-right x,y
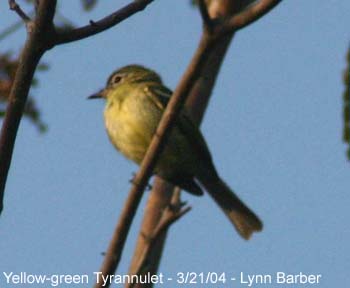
0,0 -> 350,287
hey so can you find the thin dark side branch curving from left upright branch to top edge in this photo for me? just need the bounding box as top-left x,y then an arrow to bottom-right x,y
53,0 -> 154,45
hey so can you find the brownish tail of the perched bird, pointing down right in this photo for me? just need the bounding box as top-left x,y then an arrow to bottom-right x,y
200,177 -> 263,240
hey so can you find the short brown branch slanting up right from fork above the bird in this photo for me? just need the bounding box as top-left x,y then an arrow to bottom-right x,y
223,0 -> 282,33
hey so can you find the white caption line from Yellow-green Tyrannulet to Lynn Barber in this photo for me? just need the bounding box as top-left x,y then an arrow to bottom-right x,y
0,272 -> 322,287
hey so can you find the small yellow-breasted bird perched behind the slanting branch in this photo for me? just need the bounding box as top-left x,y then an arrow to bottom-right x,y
89,65 -> 262,239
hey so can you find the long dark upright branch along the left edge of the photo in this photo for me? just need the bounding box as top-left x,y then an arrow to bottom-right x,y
0,0 -> 56,213
